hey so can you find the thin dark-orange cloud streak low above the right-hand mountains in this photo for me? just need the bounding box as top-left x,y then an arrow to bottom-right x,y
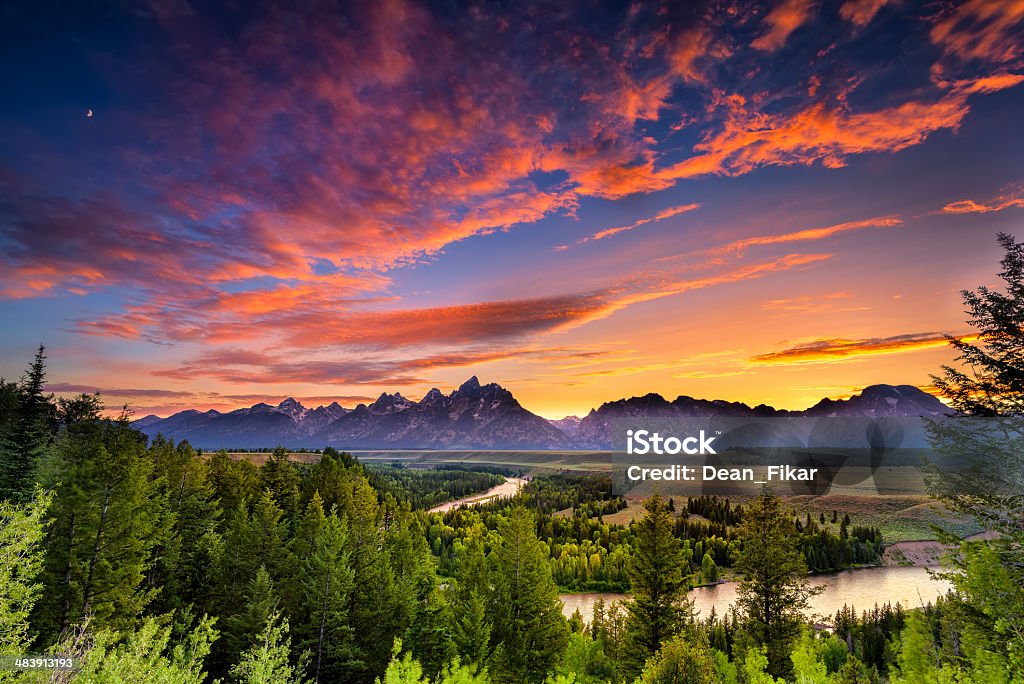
751,333 -> 977,366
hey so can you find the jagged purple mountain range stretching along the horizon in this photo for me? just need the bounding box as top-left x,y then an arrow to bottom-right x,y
133,376 -> 950,450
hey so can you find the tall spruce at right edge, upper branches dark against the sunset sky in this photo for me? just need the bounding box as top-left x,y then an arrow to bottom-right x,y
927,233 -> 1024,672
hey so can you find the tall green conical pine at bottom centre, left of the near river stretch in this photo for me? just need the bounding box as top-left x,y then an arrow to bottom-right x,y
492,506 -> 568,683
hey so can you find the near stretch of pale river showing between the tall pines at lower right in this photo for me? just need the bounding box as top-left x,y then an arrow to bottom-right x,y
559,567 -> 950,623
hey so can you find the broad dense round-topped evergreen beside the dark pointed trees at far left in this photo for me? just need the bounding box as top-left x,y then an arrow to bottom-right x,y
35,403 -> 169,639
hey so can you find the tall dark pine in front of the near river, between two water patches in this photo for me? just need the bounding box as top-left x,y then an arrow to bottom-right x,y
734,487 -> 818,677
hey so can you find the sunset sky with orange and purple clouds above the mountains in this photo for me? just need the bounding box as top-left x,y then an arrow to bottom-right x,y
0,0 -> 1024,418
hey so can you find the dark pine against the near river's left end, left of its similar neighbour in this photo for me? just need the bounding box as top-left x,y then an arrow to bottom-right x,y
626,495 -> 691,674
